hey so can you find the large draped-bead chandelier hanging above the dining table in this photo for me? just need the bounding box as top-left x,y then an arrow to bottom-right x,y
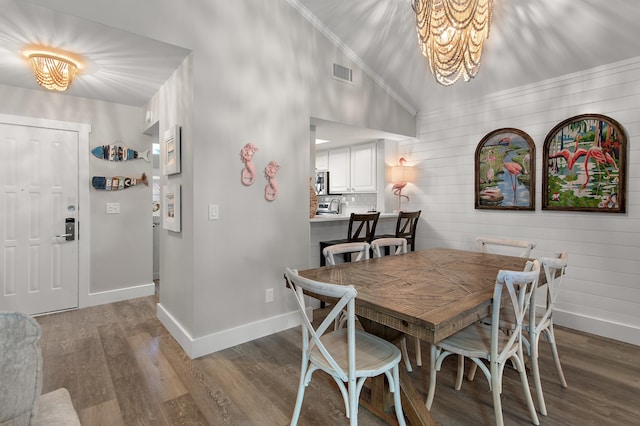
411,0 -> 493,86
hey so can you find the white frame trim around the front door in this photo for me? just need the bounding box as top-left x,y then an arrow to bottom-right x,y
0,114 -> 91,308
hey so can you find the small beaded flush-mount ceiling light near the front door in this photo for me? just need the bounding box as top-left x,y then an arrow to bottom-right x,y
23,46 -> 82,92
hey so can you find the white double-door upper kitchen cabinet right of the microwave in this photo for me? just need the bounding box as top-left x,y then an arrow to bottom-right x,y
328,142 -> 377,194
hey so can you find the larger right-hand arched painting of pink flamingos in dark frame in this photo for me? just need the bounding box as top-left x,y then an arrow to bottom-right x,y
542,114 -> 627,213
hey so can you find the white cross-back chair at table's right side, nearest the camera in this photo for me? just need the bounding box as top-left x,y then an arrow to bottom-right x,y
426,260 -> 540,426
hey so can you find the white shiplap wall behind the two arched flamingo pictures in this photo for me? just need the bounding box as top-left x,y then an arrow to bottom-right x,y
399,57 -> 640,345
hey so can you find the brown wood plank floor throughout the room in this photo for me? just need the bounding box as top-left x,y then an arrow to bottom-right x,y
37,296 -> 640,426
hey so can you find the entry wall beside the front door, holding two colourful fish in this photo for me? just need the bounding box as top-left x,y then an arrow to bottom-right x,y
0,85 -> 154,306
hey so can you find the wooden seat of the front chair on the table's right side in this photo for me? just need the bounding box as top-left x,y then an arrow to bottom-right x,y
438,323 -> 509,359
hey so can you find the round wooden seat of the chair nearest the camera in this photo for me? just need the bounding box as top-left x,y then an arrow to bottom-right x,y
309,328 -> 401,377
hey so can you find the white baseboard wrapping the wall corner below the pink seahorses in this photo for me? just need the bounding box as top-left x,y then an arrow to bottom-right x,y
157,303 -> 313,359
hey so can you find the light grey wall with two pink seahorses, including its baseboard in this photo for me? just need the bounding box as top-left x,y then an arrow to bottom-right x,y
33,0 -> 415,356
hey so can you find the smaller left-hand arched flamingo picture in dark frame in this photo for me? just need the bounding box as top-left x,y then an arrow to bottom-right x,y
475,128 -> 536,210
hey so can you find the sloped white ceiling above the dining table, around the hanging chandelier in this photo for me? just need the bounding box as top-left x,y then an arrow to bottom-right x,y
298,0 -> 640,112
